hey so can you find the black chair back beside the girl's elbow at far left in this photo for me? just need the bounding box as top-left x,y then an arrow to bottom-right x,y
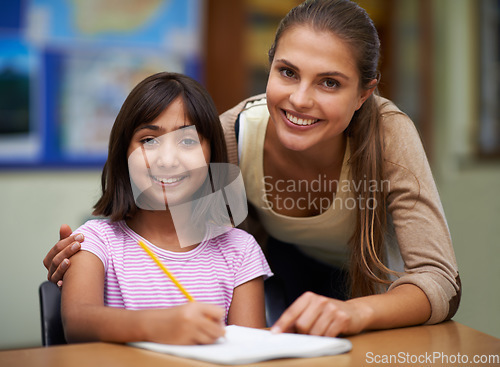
38,281 -> 66,347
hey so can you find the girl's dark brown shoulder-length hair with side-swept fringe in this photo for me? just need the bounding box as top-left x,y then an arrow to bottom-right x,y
92,72 -> 228,221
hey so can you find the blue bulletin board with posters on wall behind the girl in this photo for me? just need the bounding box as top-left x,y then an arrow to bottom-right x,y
0,0 -> 203,169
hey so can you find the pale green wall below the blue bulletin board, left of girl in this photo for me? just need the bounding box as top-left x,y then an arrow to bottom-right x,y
0,170 -> 100,349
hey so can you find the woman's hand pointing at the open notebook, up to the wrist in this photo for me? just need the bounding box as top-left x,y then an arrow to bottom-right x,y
271,292 -> 372,337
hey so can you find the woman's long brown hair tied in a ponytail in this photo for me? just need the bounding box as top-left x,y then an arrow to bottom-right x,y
269,0 -> 394,296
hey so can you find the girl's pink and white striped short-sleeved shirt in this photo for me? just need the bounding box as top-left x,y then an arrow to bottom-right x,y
75,219 -> 272,318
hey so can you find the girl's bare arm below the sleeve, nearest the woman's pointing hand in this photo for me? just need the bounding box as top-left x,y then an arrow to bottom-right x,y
227,277 -> 266,328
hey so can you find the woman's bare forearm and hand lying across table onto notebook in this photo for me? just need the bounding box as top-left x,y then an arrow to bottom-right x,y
271,284 -> 431,336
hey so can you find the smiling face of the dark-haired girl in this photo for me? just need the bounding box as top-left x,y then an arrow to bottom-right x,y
127,97 -> 210,210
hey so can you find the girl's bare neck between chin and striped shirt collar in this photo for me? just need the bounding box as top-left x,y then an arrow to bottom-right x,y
126,209 -> 198,252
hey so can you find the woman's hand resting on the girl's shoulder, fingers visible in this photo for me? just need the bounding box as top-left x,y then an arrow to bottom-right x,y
43,224 -> 84,286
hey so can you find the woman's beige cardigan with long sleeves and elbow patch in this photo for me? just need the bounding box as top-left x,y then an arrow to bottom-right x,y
221,95 -> 461,324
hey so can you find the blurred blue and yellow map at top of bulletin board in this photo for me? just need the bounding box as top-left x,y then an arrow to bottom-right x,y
28,0 -> 200,54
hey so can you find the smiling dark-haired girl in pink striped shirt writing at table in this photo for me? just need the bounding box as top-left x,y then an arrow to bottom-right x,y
62,73 -> 271,344
